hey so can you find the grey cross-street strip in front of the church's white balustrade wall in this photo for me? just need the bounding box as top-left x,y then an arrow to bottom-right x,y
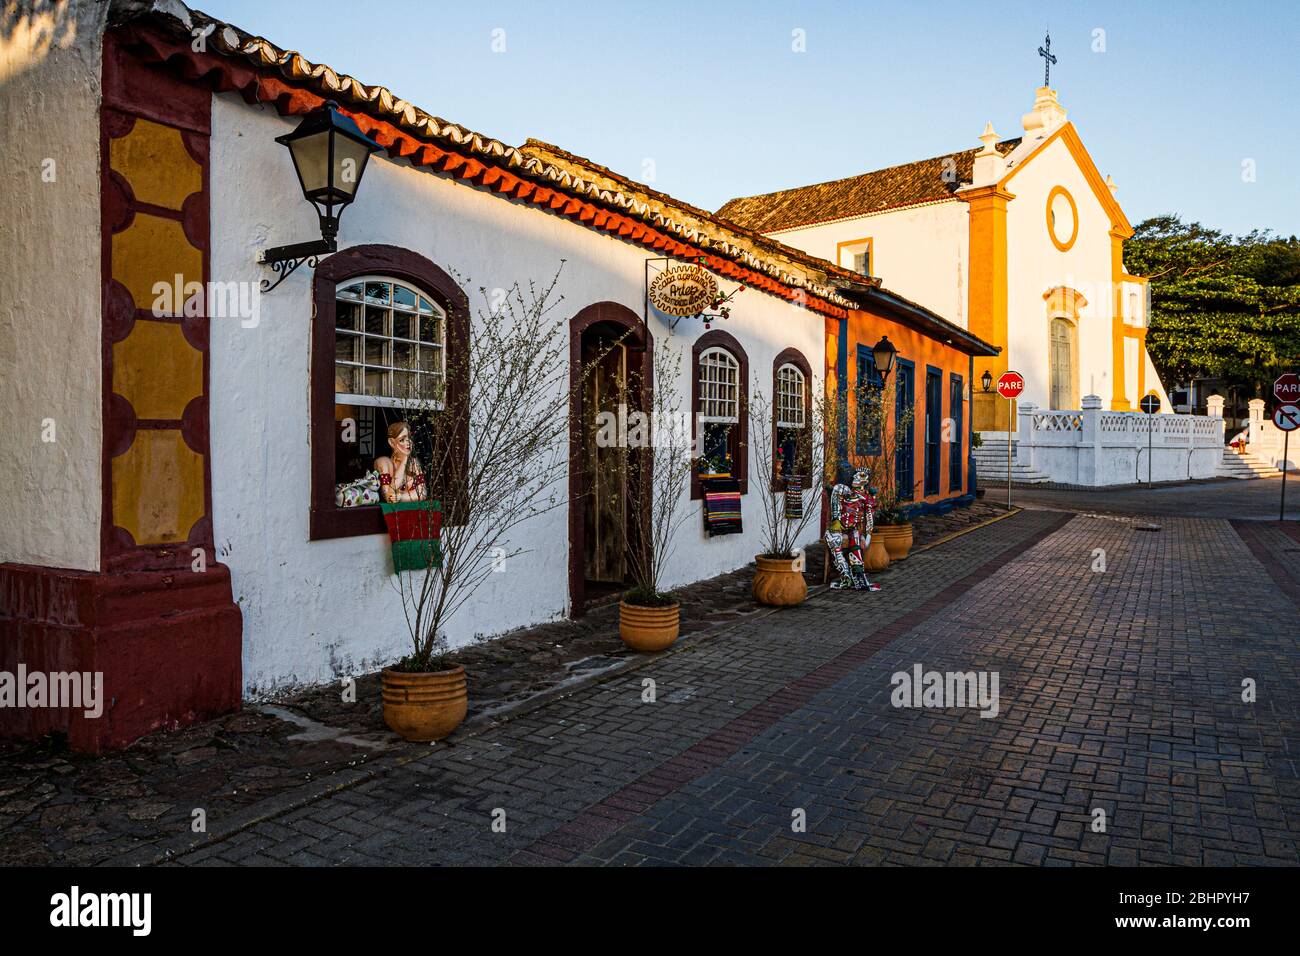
1008,475 -> 1300,522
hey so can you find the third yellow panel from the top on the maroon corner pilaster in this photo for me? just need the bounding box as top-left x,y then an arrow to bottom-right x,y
113,320 -> 203,419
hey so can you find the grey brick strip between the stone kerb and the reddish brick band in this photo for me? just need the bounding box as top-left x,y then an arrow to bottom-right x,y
134,514 -> 1086,862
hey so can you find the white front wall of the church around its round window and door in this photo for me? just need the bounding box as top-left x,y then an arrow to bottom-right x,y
1006,138 -> 1114,407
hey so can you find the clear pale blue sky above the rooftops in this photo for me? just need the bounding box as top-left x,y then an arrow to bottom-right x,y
191,0 -> 1300,235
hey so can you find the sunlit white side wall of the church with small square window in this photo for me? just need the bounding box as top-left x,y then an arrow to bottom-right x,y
771,199 -> 970,328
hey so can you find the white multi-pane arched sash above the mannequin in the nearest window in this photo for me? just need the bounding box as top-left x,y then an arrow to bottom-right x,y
334,274 -> 447,408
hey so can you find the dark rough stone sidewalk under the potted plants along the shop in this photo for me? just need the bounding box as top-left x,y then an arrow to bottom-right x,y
0,503 -> 1004,865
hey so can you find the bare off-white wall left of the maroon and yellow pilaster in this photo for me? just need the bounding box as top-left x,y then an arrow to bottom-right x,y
0,0 -> 107,571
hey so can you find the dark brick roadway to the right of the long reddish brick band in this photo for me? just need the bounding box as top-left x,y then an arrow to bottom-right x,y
577,518 -> 1300,865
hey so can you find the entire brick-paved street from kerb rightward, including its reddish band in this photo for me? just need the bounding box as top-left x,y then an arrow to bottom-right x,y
118,511 -> 1300,865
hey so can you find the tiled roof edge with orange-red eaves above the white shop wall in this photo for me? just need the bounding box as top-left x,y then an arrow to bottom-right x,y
112,0 -> 996,354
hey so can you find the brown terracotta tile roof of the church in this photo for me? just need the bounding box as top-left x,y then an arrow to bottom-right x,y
718,139 -> 1021,233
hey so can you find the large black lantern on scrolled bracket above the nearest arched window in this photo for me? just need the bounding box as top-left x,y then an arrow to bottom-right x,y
257,100 -> 382,291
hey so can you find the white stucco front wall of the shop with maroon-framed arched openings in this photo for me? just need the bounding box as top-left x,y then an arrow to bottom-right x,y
211,96 -> 824,696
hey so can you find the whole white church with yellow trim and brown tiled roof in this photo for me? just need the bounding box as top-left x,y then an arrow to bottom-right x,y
719,86 -> 1171,432
